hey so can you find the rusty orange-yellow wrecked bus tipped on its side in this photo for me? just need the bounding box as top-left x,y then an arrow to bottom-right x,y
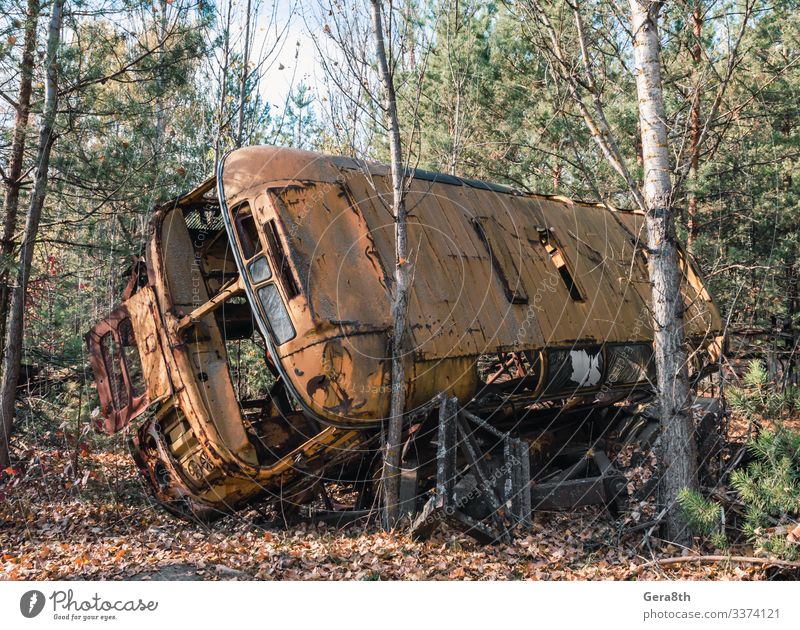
87,147 -> 721,540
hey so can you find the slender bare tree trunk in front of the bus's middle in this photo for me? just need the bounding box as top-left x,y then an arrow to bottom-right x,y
371,0 -> 411,529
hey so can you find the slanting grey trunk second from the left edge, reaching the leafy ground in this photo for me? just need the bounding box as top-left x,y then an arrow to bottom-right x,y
0,0 -> 64,469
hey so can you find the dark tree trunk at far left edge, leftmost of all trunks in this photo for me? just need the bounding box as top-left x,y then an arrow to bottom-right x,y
0,0 -> 40,363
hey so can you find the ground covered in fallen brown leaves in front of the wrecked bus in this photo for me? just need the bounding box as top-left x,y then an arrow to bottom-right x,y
0,420 -> 792,580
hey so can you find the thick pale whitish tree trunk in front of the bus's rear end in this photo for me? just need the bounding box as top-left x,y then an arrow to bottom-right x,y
629,0 -> 697,544
